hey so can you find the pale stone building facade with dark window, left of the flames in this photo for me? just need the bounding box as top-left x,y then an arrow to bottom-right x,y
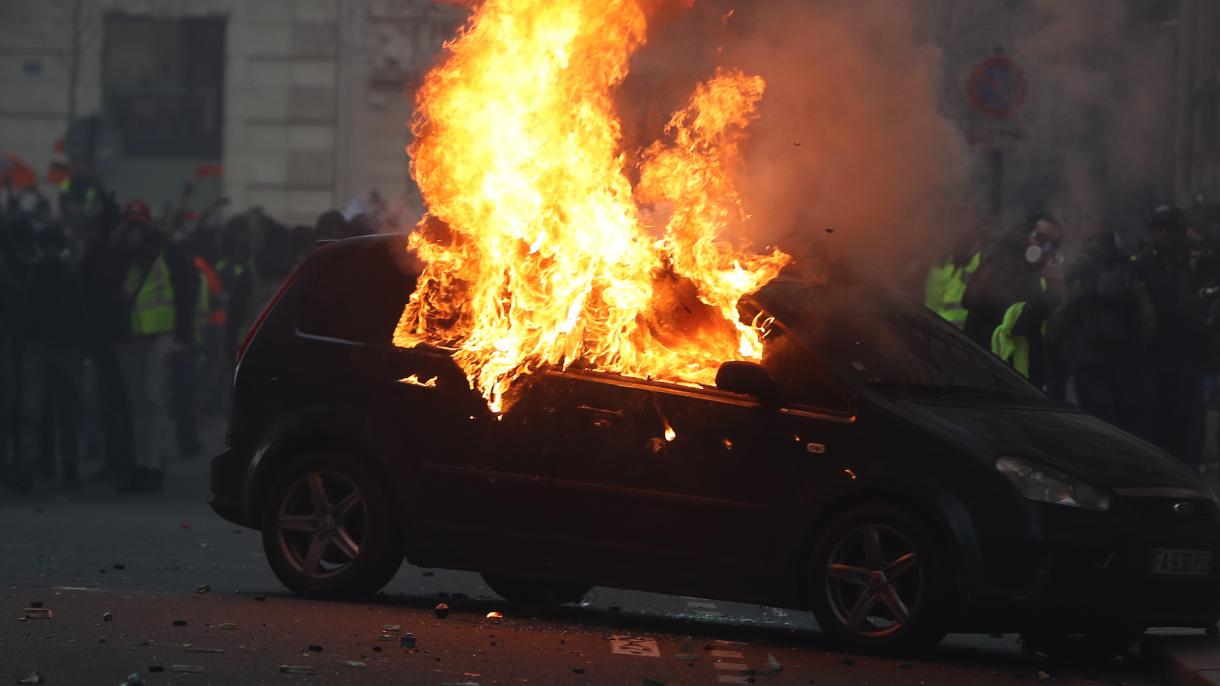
0,0 -> 464,223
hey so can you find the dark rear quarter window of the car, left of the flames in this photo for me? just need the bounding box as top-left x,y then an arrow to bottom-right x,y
296,243 -> 415,345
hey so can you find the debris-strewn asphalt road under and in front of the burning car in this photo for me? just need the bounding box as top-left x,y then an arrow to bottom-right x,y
0,434 -> 1180,686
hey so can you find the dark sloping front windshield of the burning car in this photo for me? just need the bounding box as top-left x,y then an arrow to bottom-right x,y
759,279 -> 1037,397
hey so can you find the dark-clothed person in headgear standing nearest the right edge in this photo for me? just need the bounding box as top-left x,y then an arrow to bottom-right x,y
1135,200 -> 1204,466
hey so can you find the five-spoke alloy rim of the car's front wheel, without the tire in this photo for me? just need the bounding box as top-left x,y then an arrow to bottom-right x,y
824,524 -> 925,638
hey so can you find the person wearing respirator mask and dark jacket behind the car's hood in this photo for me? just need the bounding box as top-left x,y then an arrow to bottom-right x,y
961,212 -> 1063,387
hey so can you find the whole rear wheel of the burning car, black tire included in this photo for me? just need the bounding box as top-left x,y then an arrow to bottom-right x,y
262,452 -> 403,598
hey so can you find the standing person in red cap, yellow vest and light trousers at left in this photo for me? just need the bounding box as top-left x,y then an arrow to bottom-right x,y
117,201 -> 199,492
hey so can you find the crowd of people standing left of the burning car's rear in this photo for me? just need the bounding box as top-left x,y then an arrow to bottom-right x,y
0,173 -> 383,492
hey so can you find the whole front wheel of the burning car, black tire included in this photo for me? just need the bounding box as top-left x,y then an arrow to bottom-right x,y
805,504 -> 956,653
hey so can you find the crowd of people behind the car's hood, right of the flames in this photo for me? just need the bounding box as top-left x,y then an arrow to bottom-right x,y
924,198 -> 1220,470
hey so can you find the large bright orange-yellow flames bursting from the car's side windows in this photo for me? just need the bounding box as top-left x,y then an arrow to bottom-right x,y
394,0 -> 788,413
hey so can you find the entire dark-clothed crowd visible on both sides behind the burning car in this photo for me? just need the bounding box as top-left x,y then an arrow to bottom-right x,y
7,167 -> 1220,492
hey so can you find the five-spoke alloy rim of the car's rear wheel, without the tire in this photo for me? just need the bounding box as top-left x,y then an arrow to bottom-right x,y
275,471 -> 368,580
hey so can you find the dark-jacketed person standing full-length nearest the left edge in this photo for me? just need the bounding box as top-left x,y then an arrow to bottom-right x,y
24,226 -> 84,487
